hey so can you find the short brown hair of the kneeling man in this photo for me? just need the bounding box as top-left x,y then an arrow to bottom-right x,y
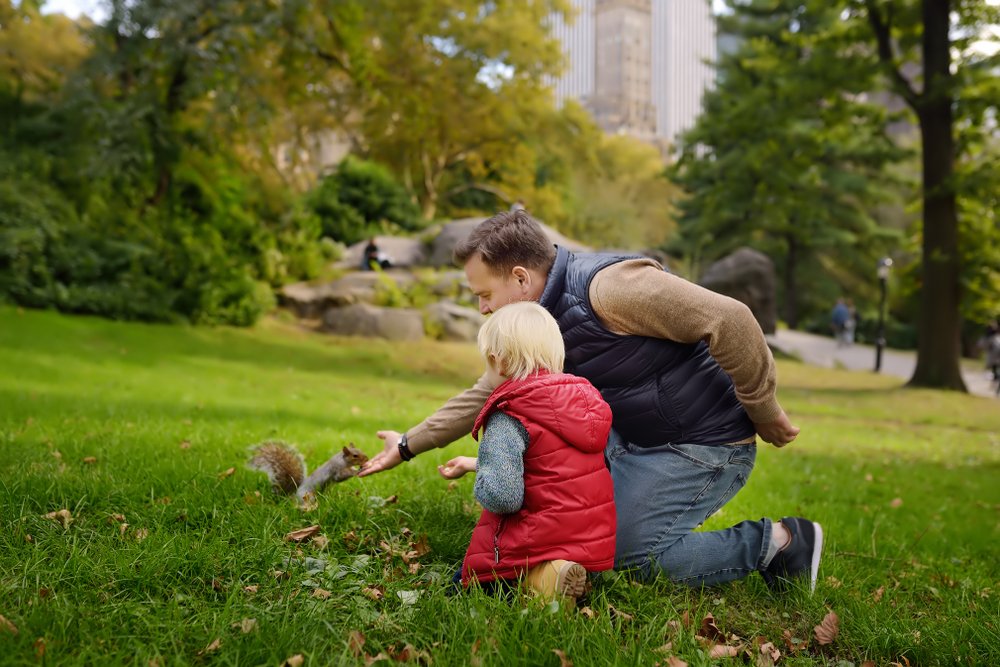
454,210 -> 556,278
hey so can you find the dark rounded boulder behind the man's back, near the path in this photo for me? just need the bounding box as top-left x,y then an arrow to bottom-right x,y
700,248 -> 778,334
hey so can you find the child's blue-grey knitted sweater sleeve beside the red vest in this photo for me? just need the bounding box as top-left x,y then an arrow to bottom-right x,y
474,410 -> 529,514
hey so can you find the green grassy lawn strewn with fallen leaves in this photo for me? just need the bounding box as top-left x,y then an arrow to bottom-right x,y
0,307 -> 1000,667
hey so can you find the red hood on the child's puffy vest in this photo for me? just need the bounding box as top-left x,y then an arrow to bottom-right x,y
472,371 -> 612,454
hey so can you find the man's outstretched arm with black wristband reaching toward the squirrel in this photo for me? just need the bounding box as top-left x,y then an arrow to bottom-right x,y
359,373 -> 493,477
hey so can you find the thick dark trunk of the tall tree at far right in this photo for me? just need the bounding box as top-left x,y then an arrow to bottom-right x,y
909,0 -> 966,391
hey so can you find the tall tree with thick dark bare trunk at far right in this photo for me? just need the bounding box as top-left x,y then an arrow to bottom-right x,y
851,0 -> 1000,391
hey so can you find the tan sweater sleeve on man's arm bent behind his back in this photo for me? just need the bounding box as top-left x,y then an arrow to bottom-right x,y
590,259 -> 781,424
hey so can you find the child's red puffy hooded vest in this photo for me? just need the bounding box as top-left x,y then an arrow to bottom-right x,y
462,372 -> 617,585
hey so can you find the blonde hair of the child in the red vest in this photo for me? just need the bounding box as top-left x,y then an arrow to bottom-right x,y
479,301 -> 566,380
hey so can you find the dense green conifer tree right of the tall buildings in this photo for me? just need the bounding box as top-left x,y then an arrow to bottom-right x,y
669,0 -> 902,328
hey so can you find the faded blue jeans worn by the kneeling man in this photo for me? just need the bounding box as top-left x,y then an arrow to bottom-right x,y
605,432 -> 771,587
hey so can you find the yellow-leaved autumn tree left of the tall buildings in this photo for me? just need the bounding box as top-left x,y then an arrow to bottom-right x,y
288,0 -> 570,220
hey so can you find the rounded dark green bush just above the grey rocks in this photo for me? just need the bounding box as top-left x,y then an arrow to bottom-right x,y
306,156 -> 422,245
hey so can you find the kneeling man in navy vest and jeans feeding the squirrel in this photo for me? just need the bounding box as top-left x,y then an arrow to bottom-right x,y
361,211 -> 823,588
